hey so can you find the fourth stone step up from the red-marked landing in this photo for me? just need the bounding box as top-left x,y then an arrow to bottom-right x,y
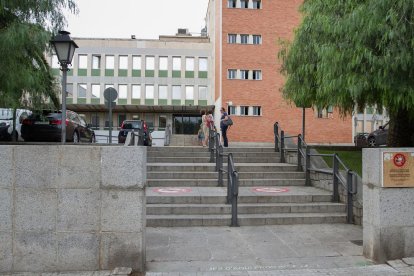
148,155 -> 280,163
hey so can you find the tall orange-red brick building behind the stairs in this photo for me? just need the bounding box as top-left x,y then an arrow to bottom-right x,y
206,0 -> 353,144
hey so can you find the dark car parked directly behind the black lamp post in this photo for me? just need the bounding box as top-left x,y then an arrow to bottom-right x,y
22,110 -> 96,143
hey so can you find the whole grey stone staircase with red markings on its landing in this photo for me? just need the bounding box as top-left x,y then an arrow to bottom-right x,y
147,147 -> 346,227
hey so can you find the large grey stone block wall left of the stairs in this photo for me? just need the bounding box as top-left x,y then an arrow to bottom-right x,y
0,145 -> 147,272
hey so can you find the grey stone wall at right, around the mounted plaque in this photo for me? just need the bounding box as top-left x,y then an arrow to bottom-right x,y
362,148 -> 414,262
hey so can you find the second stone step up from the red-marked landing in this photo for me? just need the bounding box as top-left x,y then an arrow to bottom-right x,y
147,171 -> 305,180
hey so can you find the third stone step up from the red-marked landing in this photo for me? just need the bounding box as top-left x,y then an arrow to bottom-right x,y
147,162 -> 297,173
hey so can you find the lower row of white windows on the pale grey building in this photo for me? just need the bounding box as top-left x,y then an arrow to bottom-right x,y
66,83 -> 208,100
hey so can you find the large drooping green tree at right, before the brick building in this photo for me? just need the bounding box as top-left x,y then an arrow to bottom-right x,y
279,0 -> 414,147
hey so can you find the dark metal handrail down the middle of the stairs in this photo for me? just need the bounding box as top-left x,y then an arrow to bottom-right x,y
208,125 -> 239,227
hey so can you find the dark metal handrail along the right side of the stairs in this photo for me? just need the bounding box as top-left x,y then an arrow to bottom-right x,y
274,122 -> 357,223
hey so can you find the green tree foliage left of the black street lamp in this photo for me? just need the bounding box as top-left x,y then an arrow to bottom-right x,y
0,0 -> 76,111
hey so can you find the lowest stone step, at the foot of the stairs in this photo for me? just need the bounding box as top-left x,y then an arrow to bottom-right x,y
147,213 -> 346,227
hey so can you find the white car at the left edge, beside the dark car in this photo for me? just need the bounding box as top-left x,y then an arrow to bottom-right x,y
0,108 -> 32,141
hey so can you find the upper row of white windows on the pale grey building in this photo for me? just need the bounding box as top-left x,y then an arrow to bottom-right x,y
52,54 -> 208,72
